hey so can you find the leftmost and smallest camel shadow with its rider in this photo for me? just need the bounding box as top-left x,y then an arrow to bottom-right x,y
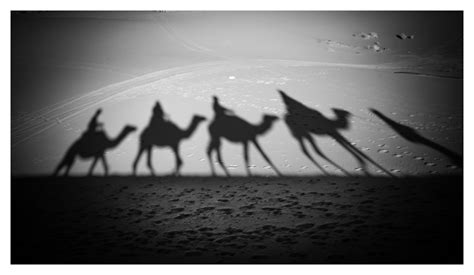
54,109 -> 137,176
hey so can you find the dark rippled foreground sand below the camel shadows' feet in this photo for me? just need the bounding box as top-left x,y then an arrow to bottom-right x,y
12,176 -> 463,264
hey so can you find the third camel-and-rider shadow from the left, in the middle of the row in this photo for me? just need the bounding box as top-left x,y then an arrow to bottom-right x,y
207,96 -> 281,176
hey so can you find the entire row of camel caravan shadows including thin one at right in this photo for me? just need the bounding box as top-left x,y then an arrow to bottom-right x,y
54,90 -> 462,177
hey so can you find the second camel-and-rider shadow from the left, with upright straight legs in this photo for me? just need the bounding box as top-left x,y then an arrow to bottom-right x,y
132,101 -> 206,175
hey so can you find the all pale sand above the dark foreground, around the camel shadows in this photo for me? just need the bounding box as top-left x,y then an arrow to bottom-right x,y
12,12 -> 463,176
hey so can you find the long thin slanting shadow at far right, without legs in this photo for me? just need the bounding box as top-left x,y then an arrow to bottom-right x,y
369,108 -> 463,166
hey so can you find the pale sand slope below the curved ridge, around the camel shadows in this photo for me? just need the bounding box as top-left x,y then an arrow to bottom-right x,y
12,60 -> 463,176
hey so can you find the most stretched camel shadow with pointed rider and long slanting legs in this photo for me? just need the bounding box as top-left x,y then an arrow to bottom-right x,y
278,90 -> 393,176
